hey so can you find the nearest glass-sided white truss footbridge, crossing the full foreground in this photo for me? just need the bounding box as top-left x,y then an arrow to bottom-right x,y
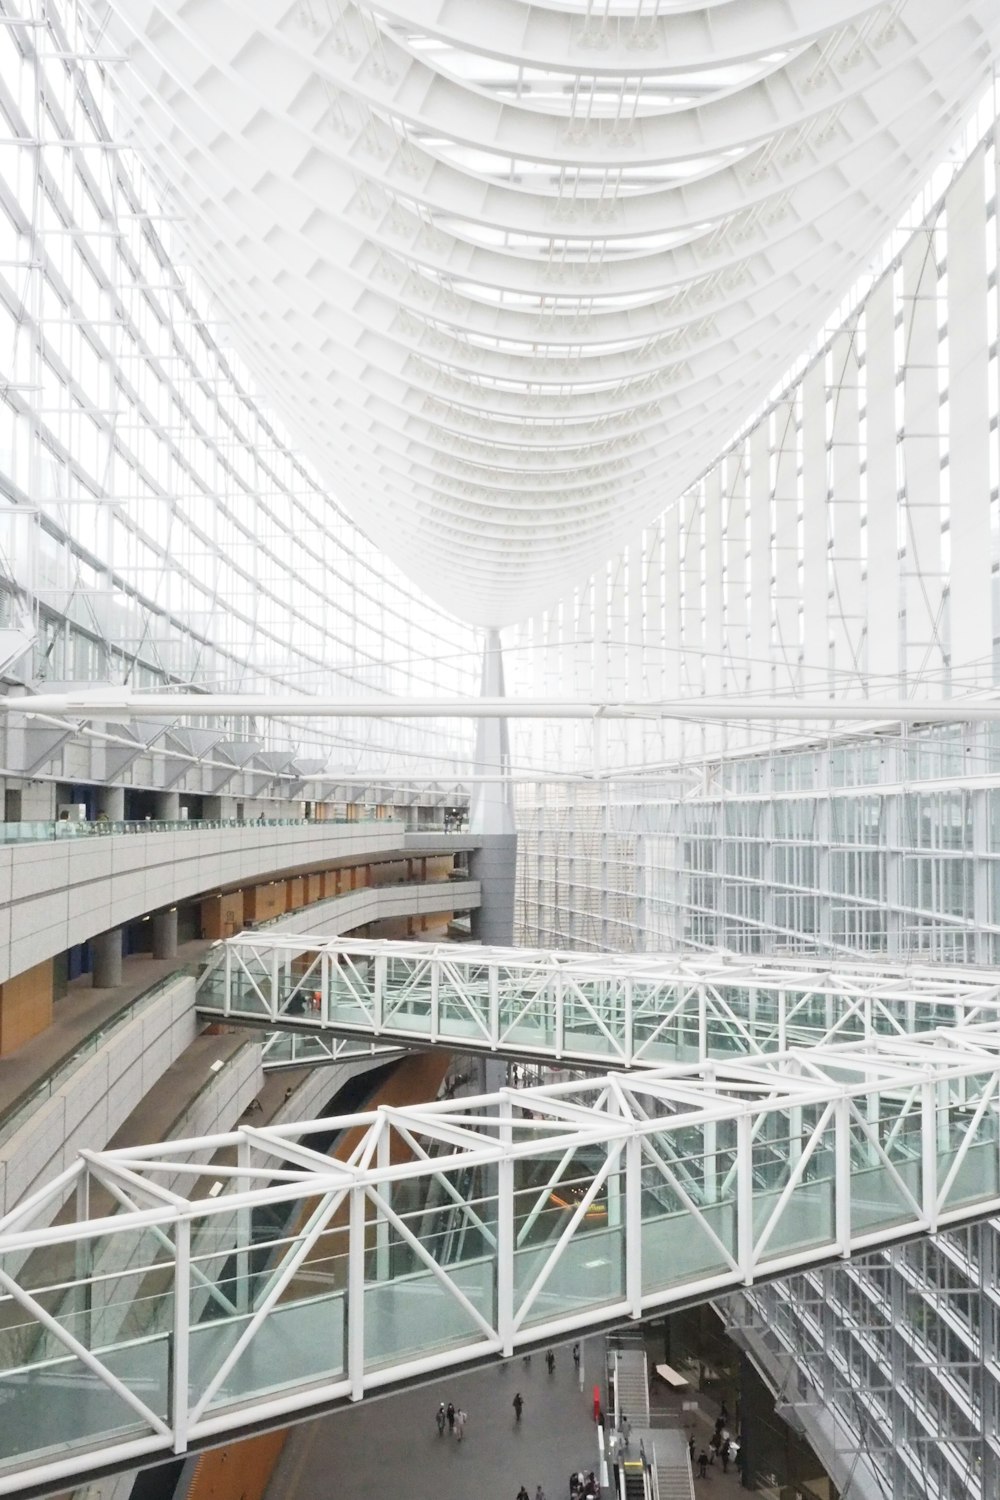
0,998 -> 1000,1494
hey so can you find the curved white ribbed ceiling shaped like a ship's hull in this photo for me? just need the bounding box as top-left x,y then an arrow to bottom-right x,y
94,0 -> 1000,624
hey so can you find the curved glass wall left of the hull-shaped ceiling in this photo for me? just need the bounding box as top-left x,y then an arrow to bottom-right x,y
0,0 -> 477,770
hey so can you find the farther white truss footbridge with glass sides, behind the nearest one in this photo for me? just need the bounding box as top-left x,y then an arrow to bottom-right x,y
196,932 -> 1000,1068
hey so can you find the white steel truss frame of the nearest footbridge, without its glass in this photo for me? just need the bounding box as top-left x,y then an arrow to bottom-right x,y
0,1025 -> 1000,1494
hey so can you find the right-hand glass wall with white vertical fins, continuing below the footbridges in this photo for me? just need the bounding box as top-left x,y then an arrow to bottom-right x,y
510,79 -> 1000,1500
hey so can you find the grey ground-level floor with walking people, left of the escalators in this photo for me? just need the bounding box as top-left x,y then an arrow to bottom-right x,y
267,1338 -> 603,1500
